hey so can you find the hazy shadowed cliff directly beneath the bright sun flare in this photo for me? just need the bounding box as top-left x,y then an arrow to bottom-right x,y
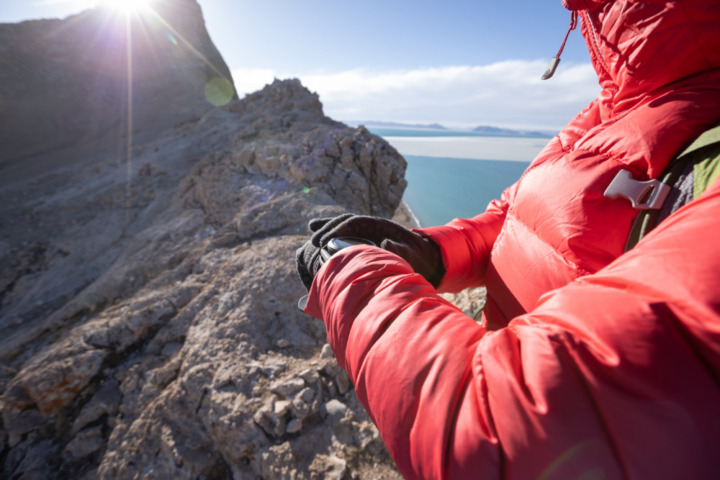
0,0 -> 236,164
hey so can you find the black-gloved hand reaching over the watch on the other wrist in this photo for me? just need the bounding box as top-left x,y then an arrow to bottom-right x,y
301,214 -> 445,287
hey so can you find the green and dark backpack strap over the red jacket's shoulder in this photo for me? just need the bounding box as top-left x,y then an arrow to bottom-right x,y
625,124 -> 720,252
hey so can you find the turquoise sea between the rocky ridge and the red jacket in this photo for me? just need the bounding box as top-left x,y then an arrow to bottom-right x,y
370,128 -> 549,227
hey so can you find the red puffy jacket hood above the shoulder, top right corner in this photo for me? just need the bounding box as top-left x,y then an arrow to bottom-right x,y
563,0 -> 720,119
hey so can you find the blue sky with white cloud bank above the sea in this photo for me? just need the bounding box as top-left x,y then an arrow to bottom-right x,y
0,0 -> 599,131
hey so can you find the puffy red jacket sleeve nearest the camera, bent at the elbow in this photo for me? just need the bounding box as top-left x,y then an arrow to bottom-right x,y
306,182 -> 720,479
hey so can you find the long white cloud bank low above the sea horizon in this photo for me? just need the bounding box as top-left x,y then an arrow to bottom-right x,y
233,60 -> 599,130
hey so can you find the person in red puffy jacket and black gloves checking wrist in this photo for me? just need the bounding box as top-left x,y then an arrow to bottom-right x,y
297,0 -> 720,479
